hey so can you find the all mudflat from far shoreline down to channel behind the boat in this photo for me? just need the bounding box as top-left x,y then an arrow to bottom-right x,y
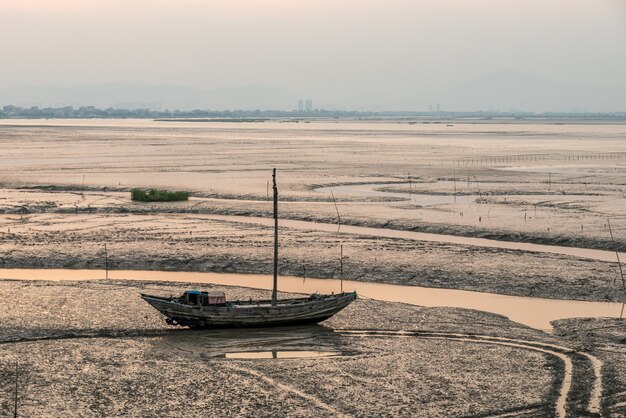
0,120 -> 626,301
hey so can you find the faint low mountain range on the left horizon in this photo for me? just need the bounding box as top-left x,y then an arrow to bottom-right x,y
0,83 -> 300,110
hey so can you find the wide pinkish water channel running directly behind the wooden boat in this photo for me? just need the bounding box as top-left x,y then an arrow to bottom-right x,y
0,269 -> 624,330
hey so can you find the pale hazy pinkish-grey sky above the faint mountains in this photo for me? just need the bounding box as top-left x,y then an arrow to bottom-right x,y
0,0 -> 626,108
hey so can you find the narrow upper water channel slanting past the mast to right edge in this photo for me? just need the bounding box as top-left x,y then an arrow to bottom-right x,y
207,215 -> 626,262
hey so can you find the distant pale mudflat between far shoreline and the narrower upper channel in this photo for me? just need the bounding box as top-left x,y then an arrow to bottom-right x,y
0,120 -> 626,249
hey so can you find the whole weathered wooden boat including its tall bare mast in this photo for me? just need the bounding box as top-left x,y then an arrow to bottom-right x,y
141,169 -> 356,328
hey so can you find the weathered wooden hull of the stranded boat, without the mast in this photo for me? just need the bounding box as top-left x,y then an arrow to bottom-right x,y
141,292 -> 356,328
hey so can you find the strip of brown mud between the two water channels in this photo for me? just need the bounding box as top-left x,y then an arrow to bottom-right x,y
0,207 -> 624,302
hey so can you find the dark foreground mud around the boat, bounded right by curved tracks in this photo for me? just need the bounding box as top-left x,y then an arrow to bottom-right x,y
0,280 -> 609,417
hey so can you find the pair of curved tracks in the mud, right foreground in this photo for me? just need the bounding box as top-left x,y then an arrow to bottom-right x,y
335,329 -> 602,418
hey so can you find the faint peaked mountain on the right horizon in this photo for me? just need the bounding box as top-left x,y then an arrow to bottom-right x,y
440,70 -> 626,112
